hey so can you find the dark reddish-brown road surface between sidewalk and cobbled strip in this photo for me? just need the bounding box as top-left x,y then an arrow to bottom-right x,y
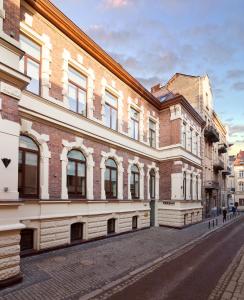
106,218 -> 244,300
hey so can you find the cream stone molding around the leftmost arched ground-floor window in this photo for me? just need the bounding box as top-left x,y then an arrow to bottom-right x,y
20,119 -> 51,199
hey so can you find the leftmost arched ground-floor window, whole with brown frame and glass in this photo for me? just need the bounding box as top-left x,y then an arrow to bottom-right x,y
18,135 -> 40,198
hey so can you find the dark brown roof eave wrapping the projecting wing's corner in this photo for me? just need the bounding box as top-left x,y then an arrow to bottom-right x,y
160,95 -> 206,128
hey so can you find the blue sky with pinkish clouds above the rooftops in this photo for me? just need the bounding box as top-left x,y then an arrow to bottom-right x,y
52,0 -> 244,154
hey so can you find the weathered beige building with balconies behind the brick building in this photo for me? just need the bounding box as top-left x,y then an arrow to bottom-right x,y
151,73 -> 230,217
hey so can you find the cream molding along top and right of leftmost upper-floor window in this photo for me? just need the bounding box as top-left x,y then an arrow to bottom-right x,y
20,21 -> 52,104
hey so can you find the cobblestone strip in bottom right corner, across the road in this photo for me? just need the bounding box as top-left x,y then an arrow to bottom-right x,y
209,246 -> 244,300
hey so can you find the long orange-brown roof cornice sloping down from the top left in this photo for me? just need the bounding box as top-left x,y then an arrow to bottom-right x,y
25,0 -> 160,109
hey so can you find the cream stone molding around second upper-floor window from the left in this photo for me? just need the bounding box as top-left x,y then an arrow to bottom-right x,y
62,49 -> 95,119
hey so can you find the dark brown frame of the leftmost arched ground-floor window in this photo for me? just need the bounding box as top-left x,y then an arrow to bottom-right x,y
18,134 -> 40,199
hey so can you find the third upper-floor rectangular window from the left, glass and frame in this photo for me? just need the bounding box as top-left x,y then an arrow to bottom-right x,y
104,91 -> 118,130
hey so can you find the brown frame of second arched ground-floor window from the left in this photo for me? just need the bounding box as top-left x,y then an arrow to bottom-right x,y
67,149 -> 87,199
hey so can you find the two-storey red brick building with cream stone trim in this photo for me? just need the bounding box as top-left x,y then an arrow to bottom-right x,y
0,0 -> 205,284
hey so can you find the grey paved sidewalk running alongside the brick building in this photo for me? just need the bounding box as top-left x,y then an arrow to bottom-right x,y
0,217 -> 240,300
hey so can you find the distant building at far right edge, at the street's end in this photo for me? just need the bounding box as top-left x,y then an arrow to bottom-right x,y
234,150 -> 244,211
